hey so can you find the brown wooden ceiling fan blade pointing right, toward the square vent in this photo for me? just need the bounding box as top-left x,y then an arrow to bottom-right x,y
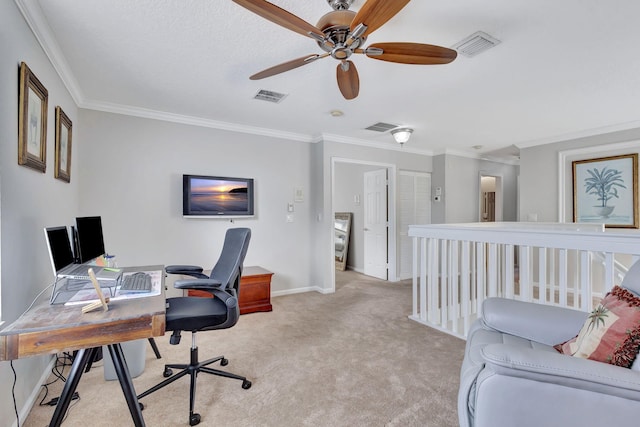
358,42 -> 458,65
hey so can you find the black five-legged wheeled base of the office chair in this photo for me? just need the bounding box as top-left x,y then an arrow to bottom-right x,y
137,346 -> 251,426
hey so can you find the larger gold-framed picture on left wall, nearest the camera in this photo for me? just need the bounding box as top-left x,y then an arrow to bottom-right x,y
18,62 -> 49,173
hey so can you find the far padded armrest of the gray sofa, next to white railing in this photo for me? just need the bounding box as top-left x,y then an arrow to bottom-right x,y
482,298 -> 588,345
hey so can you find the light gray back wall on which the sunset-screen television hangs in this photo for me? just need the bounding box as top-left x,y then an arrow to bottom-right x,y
78,110 -> 317,295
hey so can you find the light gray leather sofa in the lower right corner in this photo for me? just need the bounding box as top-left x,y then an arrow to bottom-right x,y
458,261 -> 640,427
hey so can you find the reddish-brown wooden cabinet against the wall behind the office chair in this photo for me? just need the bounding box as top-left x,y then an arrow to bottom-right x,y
188,266 -> 273,314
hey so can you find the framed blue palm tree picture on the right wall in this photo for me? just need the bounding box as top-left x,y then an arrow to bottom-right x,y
572,153 -> 639,228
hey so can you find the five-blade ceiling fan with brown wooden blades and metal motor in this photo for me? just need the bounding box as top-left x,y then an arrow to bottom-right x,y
233,0 -> 457,99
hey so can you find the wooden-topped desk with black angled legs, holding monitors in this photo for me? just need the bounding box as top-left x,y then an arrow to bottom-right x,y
0,265 -> 165,426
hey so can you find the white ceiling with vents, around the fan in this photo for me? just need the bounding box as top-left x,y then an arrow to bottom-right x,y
16,0 -> 640,159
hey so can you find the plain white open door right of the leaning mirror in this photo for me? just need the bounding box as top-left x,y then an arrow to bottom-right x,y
364,169 -> 388,280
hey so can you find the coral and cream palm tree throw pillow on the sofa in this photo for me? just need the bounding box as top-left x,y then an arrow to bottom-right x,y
554,286 -> 640,368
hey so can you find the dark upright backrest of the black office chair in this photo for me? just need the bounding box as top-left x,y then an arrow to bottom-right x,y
209,228 -> 251,296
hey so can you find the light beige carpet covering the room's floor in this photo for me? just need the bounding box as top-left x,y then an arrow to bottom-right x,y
23,272 -> 464,427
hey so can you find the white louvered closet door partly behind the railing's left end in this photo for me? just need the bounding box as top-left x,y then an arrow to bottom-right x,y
398,171 -> 431,280
